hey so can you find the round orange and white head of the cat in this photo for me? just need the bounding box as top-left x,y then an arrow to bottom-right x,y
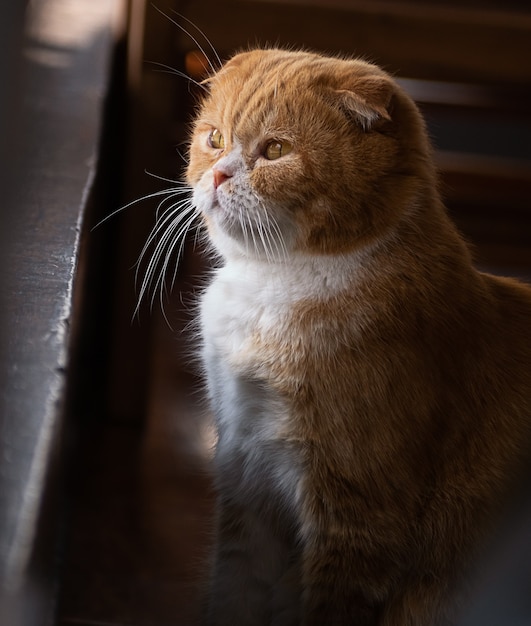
187,49 -> 433,259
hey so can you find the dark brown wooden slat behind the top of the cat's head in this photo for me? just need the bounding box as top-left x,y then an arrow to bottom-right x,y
176,0 -> 531,84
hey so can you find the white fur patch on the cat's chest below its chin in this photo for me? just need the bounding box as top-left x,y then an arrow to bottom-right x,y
201,252 -> 362,508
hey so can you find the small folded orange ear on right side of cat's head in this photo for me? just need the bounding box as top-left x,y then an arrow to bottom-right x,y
334,76 -> 395,131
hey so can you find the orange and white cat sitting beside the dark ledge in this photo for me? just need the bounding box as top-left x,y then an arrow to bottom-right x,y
181,48 -> 531,626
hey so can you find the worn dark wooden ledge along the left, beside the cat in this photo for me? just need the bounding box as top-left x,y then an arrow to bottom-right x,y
0,0 -> 118,626
